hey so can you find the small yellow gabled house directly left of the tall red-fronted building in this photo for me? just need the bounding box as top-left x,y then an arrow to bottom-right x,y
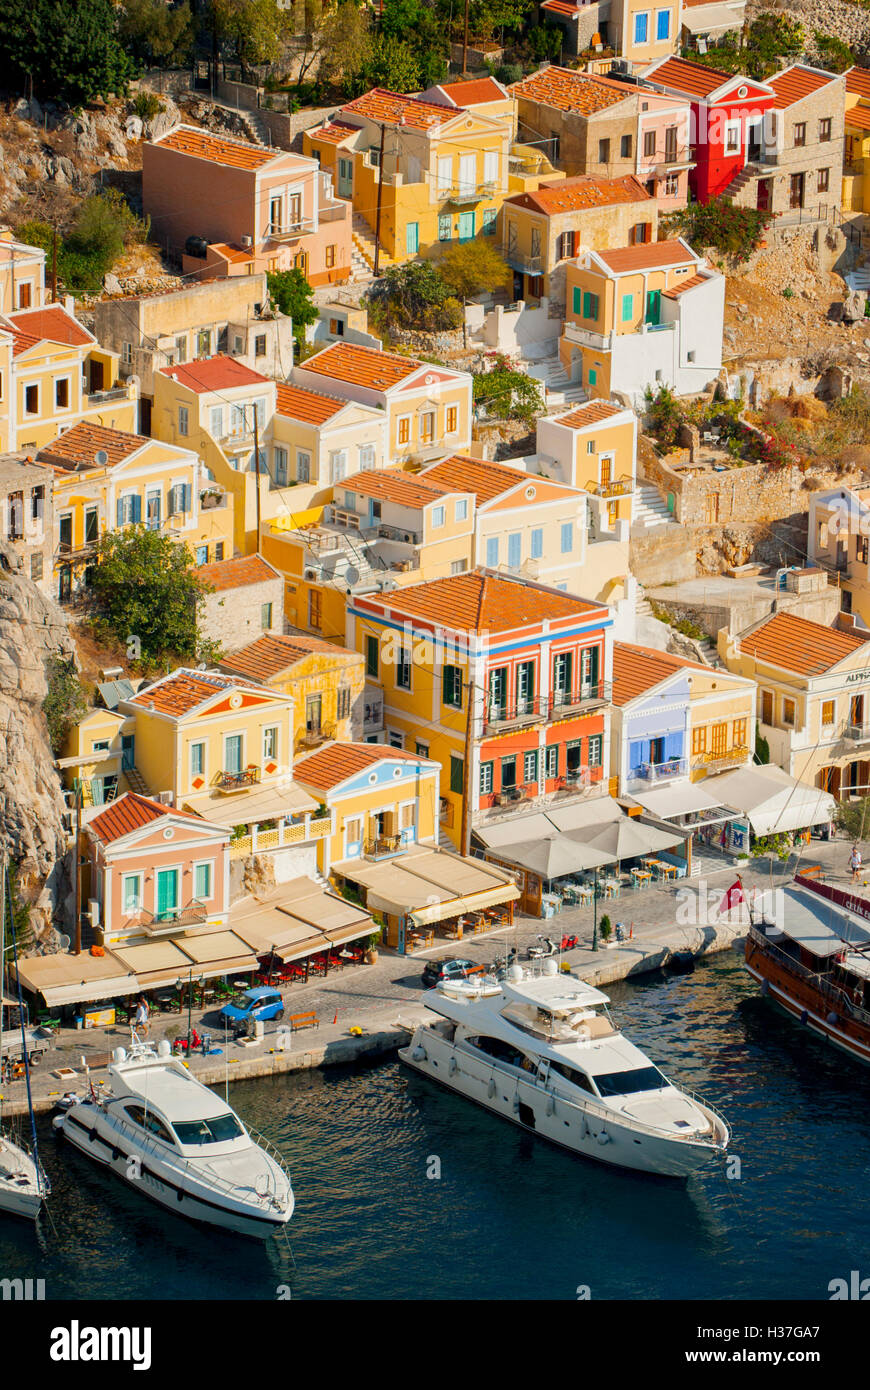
296,744 -> 441,874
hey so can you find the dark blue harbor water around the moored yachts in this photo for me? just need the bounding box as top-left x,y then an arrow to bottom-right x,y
0,952 -> 870,1300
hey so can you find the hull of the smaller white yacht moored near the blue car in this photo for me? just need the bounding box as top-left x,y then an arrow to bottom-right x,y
54,1106 -> 293,1240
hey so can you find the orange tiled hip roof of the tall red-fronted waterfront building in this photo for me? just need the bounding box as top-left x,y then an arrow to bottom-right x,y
366,570 -> 607,634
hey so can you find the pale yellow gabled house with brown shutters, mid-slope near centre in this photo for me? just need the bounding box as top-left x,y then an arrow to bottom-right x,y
293,342 -> 471,471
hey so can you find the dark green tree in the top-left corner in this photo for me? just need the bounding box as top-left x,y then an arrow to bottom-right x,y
0,0 -> 136,106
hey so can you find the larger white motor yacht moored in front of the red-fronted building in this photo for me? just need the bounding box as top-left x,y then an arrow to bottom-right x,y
399,960 -> 730,1177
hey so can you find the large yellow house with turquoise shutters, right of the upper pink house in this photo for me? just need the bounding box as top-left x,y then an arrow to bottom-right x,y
303,85 -> 513,270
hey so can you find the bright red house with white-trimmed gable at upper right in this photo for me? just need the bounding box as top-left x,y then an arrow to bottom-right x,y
641,58 -> 775,203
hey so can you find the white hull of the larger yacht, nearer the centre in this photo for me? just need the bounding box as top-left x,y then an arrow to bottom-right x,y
399,1024 -> 724,1179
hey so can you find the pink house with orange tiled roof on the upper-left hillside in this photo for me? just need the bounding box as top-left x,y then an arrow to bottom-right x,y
142,125 -> 352,285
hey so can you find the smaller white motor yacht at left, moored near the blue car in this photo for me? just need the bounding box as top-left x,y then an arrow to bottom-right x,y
54,1041 -> 293,1237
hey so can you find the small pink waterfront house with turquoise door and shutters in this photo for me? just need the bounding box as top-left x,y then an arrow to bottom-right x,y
83,791 -> 231,945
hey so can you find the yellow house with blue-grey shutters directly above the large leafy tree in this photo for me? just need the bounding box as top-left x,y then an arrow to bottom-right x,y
36,421 -> 232,602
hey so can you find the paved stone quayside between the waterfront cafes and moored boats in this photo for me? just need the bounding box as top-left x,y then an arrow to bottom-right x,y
4,838 -> 870,1099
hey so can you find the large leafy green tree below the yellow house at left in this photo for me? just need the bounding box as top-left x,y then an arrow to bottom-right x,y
93,525 -> 218,669
